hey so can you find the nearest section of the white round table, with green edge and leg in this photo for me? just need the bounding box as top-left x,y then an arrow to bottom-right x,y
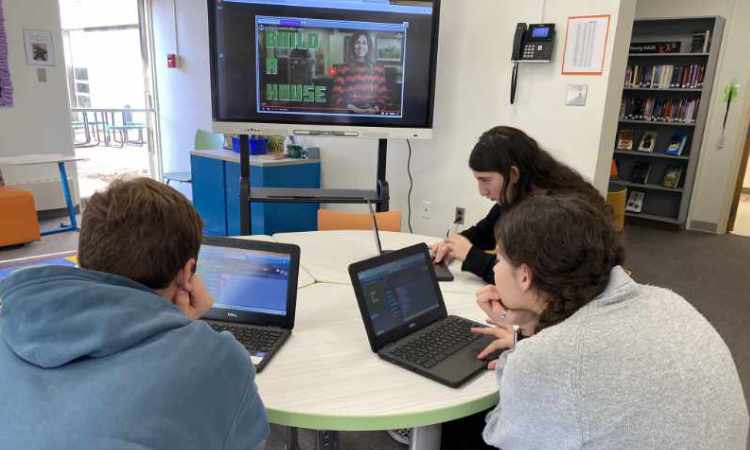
256,282 -> 498,450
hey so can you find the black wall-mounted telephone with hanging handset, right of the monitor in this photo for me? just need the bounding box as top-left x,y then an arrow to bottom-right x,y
510,22 -> 555,105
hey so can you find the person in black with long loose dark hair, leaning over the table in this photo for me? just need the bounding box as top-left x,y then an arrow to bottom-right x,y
431,126 -> 608,283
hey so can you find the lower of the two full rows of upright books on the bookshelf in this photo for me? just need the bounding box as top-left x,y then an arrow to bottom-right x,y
620,97 -> 699,124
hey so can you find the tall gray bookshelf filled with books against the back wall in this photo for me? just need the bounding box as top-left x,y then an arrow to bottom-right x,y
610,16 -> 724,228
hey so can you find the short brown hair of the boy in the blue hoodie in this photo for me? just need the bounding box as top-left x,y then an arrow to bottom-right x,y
78,178 -> 203,289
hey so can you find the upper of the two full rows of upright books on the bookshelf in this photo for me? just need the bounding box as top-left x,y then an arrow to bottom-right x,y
625,64 -> 706,89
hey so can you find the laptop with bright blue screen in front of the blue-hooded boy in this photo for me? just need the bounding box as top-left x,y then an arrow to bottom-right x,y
198,237 -> 300,372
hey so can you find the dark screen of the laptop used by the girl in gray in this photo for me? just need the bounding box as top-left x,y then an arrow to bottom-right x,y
357,253 -> 440,336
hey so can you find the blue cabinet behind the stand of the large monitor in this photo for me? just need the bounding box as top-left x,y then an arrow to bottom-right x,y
190,150 -> 320,236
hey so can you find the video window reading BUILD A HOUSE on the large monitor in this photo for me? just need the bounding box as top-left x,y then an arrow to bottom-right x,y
255,16 -> 409,119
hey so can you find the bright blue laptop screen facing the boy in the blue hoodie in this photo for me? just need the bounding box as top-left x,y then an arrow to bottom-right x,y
198,244 -> 291,316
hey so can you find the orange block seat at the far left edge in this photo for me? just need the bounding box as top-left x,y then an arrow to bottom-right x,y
0,186 -> 41,247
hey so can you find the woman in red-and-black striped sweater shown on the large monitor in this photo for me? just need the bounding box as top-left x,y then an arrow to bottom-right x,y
333,31 -> 388,114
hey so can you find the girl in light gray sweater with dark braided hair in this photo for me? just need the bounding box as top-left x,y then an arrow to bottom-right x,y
476,196 -> 748,450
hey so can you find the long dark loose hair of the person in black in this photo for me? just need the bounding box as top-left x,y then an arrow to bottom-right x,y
469,126 -> 606,208
